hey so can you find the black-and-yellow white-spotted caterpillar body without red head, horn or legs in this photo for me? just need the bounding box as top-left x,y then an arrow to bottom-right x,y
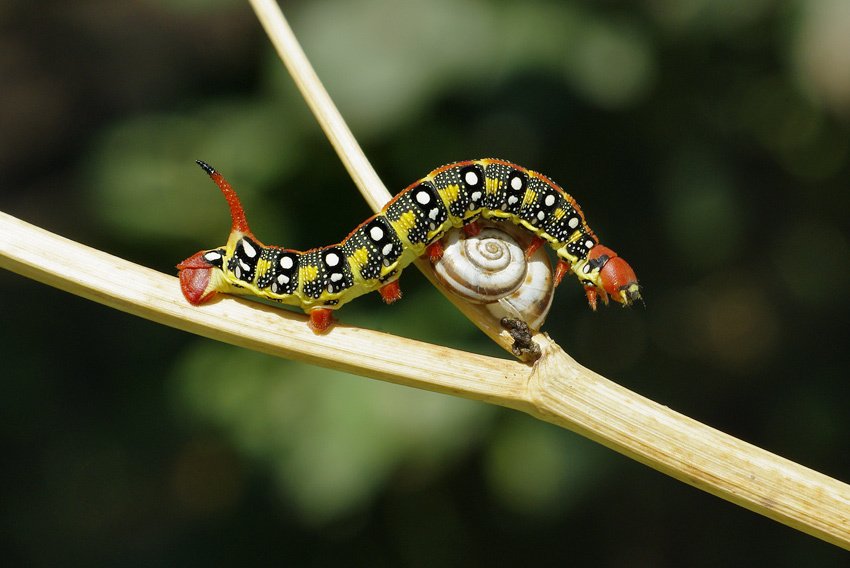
204,159 -> 599,311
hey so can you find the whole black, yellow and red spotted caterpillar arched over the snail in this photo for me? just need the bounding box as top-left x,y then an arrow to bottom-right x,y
177,158 -> 641,333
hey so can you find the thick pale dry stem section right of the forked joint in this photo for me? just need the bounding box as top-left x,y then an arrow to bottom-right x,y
529,343 -> 850,549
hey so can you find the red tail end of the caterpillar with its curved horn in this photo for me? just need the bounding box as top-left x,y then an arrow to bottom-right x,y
177,160 -> 251,306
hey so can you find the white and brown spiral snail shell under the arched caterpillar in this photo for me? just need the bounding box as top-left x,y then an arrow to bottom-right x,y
434,221 -> 555,330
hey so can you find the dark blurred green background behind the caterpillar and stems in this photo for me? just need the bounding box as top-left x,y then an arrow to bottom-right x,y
0,0 -> 850,567
